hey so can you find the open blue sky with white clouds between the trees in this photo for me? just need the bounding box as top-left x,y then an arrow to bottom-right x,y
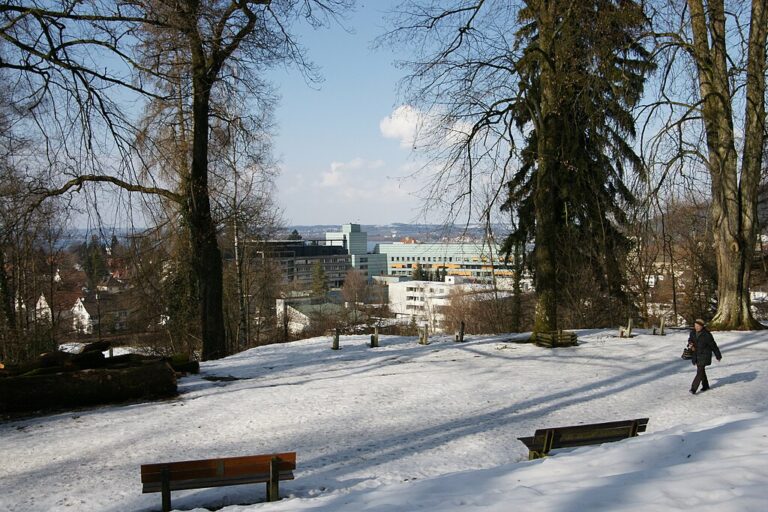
274,0 -> 426,225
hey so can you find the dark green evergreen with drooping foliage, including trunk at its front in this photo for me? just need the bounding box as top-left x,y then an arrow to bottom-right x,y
502,0 -> 652,331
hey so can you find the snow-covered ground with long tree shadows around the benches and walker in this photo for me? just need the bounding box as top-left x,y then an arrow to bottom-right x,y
0,331 -> 768,512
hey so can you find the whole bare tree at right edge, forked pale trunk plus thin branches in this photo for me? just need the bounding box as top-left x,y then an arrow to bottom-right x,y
654,0 -> 768,329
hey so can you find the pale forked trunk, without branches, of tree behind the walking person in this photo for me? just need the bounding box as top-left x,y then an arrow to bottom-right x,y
688,0 -> 768,329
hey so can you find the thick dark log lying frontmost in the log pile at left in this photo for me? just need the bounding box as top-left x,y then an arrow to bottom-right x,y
0,362 -> 177,413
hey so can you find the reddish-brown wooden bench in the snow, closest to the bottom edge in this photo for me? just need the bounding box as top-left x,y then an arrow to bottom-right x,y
141,452 -> 296,512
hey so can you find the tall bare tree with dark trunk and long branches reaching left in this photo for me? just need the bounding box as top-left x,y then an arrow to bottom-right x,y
0,0 -> 352,359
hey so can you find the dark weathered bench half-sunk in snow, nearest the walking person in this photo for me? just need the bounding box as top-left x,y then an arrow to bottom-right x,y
518,418 -> 648,460
